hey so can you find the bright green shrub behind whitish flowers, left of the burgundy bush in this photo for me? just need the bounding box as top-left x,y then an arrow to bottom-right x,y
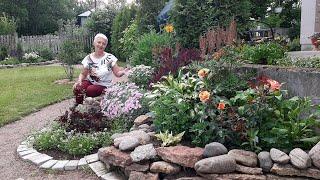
130,31 -> 172,67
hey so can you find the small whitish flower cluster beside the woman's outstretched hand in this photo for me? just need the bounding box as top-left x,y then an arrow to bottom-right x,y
128,64 -> 154,88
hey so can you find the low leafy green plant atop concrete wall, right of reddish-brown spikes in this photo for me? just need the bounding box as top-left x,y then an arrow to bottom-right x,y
242,42 -> 285,65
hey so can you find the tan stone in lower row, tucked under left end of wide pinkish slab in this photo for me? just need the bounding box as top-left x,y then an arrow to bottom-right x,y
150,161 -> 181,174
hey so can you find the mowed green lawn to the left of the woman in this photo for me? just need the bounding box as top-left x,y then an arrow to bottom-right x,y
0,66 -> 79,127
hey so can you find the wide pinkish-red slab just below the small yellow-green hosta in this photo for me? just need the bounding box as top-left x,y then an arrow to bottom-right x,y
156,146 -> 203,168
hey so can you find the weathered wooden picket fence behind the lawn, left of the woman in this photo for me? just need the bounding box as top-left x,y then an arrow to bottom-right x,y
0,33 -> 93,54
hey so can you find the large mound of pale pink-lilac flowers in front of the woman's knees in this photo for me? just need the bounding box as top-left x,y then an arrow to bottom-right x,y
100,83 -> 143,119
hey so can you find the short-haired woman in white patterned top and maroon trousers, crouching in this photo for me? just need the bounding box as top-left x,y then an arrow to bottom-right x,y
73,33 -> 128,106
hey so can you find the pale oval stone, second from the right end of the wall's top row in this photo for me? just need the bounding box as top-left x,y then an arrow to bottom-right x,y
289,148 -> 310,169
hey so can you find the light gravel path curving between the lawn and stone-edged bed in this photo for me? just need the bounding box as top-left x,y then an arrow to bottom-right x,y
0,100 -> 98,180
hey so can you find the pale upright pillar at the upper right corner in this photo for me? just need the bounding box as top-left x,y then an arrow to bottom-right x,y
300,0 -> 320,51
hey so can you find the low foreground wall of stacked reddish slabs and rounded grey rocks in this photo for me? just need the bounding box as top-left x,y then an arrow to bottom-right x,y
98,115 -> 320,180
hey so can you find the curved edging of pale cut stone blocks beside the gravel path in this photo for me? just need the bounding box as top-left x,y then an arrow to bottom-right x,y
17,137 -> 121,180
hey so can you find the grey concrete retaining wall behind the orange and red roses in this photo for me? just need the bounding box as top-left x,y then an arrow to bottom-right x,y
238,64 -> 320,104
